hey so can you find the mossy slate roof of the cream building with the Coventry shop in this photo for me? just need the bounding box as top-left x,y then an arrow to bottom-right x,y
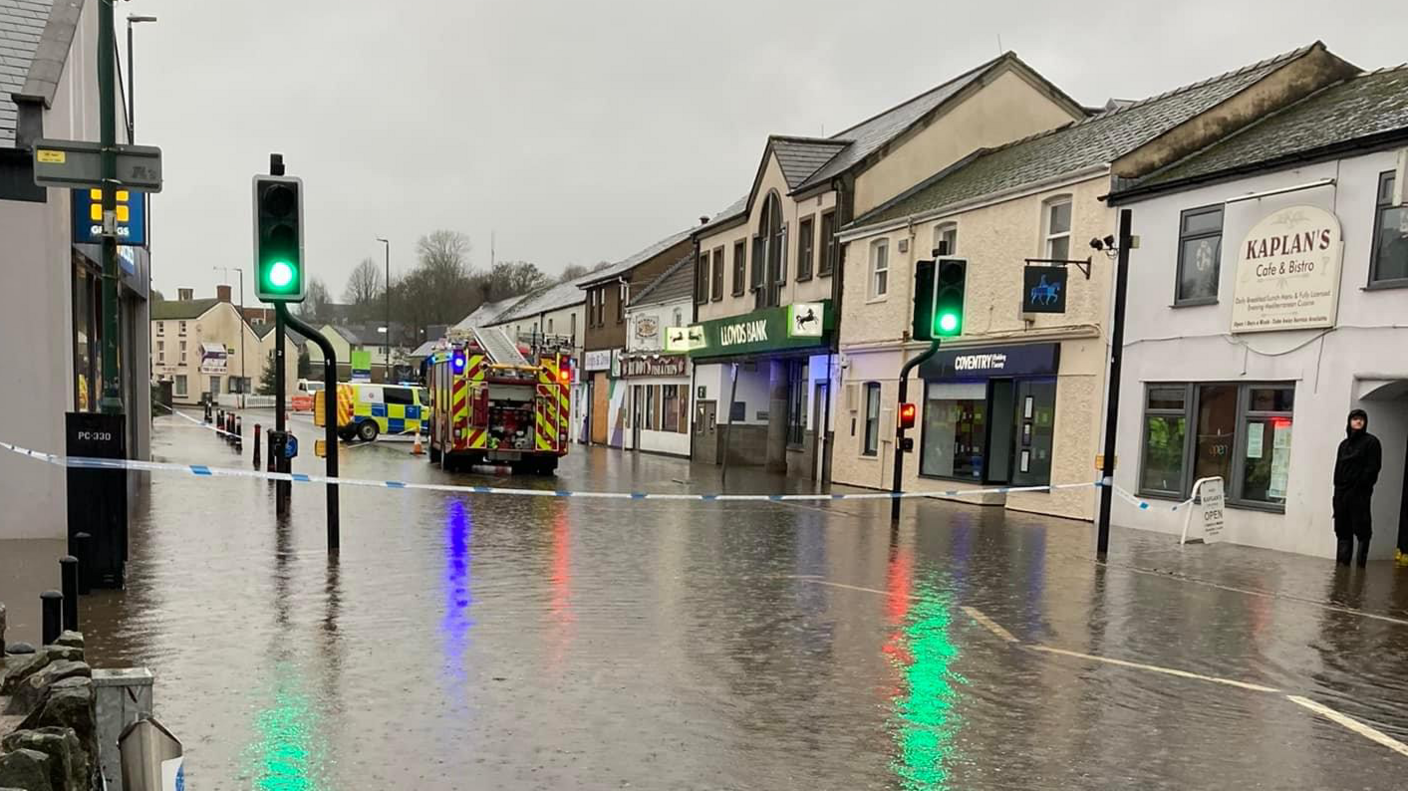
852,45 -> 1315,227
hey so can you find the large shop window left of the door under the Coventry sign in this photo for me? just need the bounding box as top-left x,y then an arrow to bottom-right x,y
919,381 -> 987,480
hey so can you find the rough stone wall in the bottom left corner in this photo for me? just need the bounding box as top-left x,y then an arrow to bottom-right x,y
0,628 -> 97,791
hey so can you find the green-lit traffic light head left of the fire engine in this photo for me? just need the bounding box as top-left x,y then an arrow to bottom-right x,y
255,176 -> 307,303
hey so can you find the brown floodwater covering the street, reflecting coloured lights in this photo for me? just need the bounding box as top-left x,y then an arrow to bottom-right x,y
8,408 -> 1408,791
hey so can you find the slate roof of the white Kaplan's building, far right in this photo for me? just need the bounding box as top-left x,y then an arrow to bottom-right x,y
1122,65 -> 1408,193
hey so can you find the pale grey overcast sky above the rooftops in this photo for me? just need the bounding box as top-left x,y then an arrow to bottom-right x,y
134,0 -> 1408,301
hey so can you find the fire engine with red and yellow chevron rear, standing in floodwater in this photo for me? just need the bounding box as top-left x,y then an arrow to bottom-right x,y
427,328 -> 572,474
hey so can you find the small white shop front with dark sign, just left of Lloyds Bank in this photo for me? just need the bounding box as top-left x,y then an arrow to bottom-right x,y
614,352 -> 690,456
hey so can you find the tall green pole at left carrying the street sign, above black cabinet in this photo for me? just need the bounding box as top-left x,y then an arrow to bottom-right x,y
97,1 -> 122,415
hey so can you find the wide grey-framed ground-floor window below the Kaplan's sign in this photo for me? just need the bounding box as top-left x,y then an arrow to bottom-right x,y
1139,383 -> 1295,510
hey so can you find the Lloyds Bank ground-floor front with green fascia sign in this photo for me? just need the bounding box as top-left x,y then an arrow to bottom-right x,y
684,300 -> 839,479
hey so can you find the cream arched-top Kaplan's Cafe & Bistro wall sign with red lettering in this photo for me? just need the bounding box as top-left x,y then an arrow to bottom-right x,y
1232,205 -> 1343,332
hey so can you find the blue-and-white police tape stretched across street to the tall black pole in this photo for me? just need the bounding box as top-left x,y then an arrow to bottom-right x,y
0,433 -> 1120,502
